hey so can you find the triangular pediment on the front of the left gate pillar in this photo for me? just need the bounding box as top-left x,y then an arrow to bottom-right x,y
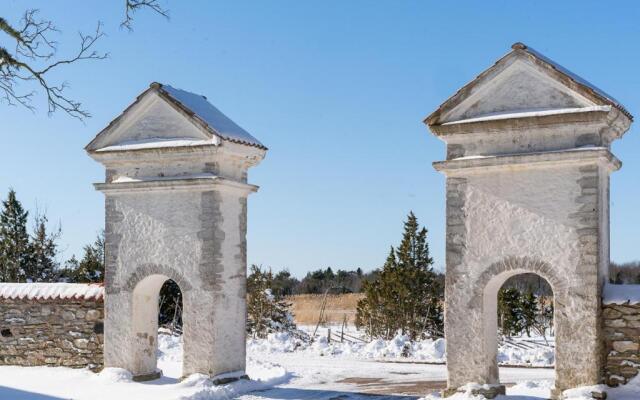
87,89 -> 213,151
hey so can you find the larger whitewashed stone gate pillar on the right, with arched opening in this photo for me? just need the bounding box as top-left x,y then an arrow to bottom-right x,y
425,43 -> 632,391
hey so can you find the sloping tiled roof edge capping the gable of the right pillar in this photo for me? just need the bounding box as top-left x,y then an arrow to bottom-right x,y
424,42 -> 633,126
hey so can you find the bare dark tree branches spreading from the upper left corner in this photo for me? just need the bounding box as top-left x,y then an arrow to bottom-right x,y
0,10 -> 108,120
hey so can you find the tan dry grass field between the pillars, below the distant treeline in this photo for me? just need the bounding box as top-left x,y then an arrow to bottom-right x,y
287,293 -> 363,325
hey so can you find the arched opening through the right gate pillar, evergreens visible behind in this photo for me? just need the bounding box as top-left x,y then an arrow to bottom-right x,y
483,270 -> 556,387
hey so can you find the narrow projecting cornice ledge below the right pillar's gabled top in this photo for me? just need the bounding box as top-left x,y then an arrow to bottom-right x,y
433,147 -> 622,175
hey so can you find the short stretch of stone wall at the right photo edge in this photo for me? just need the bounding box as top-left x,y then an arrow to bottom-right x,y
602,304 -> 640,386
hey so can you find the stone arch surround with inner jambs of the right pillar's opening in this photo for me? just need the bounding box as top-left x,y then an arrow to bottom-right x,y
470,256 -> 568,390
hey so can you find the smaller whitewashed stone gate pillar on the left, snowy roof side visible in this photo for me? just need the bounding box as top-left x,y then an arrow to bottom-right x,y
86,83 -> 266,379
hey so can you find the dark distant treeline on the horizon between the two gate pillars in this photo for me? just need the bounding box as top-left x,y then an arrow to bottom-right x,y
272,267 -> 444,296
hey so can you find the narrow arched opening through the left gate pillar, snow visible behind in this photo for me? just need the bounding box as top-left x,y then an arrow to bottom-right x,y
132,274 -> 182,381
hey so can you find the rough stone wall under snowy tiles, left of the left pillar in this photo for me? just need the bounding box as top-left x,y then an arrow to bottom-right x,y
0,298 -> 103,370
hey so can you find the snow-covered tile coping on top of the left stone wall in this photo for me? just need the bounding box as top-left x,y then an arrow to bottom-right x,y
0,282 -> 104,301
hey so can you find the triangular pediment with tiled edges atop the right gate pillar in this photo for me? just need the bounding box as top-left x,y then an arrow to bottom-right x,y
425,43 -> 630,126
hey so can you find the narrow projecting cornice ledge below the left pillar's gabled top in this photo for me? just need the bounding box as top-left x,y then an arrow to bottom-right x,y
93,176 -> 258,195
